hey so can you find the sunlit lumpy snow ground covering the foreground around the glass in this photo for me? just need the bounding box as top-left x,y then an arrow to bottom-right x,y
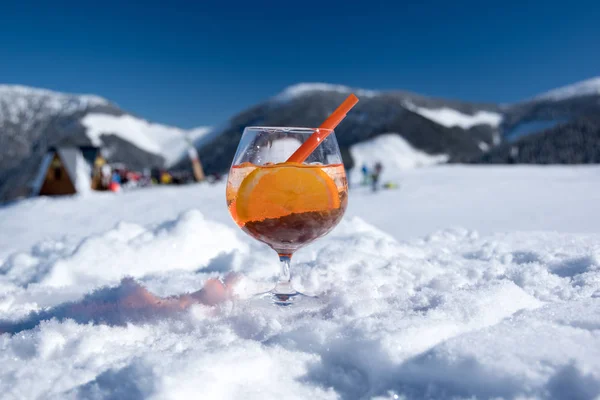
0,166 -> 600,399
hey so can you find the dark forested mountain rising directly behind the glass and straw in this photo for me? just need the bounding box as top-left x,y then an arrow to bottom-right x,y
184,83 -> 503,173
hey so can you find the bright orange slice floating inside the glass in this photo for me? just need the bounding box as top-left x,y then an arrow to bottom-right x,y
235,163 -> 340,223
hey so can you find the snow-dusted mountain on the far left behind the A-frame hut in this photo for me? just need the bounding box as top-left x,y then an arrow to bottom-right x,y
0,85 -> 211,200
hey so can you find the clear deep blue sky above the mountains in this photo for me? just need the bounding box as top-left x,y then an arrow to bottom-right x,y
0,0 -> 600,128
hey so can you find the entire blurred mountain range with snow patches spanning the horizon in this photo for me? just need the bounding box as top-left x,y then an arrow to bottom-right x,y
0,77 -> 600,203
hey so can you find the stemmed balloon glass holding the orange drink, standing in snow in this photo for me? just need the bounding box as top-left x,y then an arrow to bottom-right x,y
226,127 -> 348,306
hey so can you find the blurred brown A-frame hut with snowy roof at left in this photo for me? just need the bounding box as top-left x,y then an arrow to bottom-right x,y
32,147 -> 98,196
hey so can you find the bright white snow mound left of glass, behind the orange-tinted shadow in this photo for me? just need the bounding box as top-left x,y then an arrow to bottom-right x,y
40,211 -> 246,286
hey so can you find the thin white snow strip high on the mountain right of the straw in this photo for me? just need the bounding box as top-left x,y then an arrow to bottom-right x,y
404,101 -> 503,129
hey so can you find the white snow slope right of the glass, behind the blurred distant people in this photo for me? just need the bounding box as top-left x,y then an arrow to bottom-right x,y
350,133 -> 448,182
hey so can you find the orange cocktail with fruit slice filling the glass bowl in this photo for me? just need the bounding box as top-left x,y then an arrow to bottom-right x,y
227,162 -> 348,256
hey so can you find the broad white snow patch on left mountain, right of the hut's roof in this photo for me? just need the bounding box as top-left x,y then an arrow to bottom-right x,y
81,113 -> 202,166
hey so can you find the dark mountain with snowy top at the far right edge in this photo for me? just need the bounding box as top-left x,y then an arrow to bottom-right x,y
486,77 -> 600,164
